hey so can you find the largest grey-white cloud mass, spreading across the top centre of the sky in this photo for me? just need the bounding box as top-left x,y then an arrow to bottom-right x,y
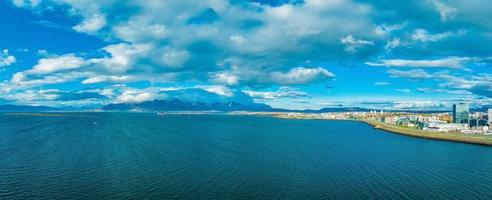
7,0 -> 372,88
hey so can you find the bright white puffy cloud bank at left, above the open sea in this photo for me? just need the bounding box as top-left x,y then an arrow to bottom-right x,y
8,43 -> 180,87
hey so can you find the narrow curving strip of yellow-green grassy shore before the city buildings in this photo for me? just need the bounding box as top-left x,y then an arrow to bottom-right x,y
358,120 -> 492,146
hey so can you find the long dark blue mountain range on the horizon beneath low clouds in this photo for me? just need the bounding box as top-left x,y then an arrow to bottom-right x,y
102,99 -> 275,111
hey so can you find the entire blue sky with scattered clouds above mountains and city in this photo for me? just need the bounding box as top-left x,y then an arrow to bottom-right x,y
0,0 -> 492,110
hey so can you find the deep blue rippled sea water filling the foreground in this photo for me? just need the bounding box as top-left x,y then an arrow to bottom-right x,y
0,113 -> 492,199
